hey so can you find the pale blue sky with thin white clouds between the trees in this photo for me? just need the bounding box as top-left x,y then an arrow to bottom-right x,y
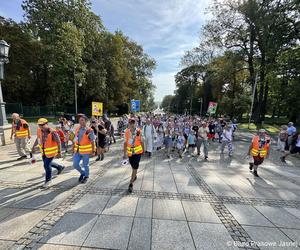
0,0 -> 210,102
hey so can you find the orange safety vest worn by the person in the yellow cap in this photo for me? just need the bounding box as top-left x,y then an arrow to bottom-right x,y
37,128 -> 58,158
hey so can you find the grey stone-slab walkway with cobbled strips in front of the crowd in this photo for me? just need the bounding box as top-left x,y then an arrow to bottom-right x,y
0,133 -> 300,249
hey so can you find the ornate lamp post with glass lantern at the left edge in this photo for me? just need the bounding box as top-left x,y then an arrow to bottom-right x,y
0,40 -> 10,145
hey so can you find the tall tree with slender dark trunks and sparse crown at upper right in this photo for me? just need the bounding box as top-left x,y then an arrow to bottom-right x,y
182,0 -> 300,123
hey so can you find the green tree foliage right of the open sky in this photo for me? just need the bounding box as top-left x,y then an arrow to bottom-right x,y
177,0 -> 300,123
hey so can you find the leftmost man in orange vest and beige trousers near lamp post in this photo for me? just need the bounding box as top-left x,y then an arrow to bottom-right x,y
10,113 -> 31,160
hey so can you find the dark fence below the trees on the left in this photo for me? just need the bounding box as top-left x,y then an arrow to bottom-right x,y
5,103 -> 91,117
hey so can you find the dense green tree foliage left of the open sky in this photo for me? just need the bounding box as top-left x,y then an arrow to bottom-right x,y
0,0 -> 155,112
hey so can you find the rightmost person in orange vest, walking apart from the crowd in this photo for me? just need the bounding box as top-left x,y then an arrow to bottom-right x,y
248,129 -> 270,177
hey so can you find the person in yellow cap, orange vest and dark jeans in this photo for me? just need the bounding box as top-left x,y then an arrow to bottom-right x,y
31,118 -> 65,188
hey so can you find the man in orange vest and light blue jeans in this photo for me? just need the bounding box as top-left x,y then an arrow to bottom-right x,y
73,115 -> 95,183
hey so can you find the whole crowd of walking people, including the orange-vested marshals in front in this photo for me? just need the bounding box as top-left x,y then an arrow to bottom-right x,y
11,113 -> 300,192
